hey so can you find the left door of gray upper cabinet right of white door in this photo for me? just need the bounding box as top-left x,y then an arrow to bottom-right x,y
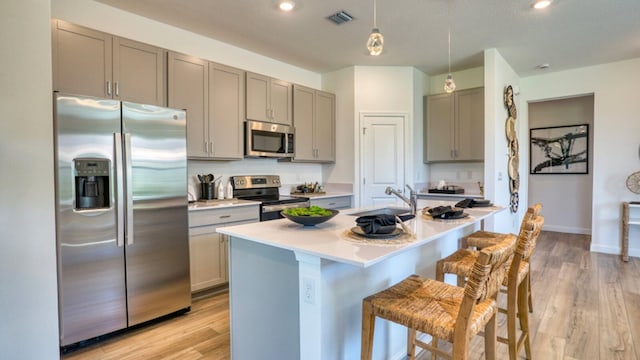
424,94 -> 454,162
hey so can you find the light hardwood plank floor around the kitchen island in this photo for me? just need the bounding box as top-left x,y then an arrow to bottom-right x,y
62,232 -> 640,360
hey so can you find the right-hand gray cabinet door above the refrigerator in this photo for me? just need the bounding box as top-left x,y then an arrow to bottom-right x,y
113,37 -> 165,106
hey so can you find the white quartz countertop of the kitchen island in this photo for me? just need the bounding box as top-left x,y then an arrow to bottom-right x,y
216,200 -> 505,267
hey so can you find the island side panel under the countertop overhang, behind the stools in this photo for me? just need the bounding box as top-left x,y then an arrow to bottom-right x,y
316,226 -> 464,360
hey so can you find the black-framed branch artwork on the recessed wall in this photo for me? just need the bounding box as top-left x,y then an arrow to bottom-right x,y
529,124 -> 589,174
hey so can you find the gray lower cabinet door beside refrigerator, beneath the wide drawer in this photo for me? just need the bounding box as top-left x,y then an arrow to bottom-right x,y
189,226 -> 227,292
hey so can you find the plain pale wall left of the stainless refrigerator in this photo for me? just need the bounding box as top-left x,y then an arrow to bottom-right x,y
0,0 -> 59,360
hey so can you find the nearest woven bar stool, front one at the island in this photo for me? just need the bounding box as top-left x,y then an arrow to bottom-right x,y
361,236 -> 516,360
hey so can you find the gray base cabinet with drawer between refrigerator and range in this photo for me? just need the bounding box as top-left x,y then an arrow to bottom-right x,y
189,205 -> 260,292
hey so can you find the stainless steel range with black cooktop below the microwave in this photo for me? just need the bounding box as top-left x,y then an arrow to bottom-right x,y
231,175 -> 309,221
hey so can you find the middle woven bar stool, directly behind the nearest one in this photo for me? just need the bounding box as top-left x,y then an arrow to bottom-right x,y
436,216 -> 544,360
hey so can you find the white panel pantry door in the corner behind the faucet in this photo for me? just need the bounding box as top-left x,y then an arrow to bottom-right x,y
360,115 -> 404,206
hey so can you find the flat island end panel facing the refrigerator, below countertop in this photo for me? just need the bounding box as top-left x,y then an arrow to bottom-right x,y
229,237 -> 300,360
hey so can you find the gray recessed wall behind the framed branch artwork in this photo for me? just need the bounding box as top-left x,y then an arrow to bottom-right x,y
521,95 -> 595,234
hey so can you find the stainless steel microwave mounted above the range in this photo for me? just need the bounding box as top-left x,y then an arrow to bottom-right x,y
244,120 -> 293,158
